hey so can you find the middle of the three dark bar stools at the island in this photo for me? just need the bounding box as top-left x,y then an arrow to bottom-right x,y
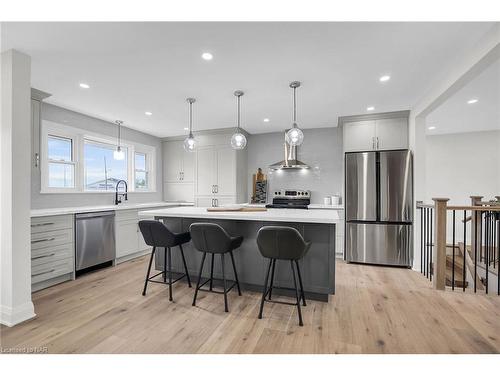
189,223 -> 243,312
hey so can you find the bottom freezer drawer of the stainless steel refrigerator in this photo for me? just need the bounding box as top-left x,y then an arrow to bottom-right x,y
345,223 -> 413,267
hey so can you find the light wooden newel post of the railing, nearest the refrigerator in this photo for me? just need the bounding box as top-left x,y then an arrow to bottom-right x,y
432,198 -> 449,290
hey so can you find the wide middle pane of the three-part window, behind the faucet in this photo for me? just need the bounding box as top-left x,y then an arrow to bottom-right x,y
83,140 -> 128,191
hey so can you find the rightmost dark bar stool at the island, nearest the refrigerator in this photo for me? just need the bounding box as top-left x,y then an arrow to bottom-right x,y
257,226 -> 311,326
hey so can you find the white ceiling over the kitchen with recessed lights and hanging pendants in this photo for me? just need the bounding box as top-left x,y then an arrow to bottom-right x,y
1,22 -> 493,136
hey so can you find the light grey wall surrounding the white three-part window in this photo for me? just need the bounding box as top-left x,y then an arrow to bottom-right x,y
31,103 -> 163,209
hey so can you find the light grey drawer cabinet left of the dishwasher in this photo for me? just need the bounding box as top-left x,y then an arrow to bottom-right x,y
31,215 -> 75,292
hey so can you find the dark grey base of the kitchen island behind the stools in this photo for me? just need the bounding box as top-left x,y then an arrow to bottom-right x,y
150,217 -> 335,301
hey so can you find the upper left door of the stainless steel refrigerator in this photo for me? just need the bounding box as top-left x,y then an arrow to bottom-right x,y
345,152 -> 377,221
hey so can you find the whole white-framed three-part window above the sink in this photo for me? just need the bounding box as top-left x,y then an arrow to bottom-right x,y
40,120 -> 156,193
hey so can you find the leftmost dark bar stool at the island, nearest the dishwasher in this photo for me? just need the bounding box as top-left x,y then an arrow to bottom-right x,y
139,220 -> 191,301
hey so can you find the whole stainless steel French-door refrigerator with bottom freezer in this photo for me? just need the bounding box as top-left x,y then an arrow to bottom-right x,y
345,150 -> 413,267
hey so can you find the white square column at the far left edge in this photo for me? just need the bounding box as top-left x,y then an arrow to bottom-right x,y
0,50 -> 35,326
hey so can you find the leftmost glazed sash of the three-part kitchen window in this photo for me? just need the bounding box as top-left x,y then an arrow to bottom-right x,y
47,135 -> 75,189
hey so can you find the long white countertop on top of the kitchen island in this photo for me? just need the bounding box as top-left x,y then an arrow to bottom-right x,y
139,207 -> 342,224
